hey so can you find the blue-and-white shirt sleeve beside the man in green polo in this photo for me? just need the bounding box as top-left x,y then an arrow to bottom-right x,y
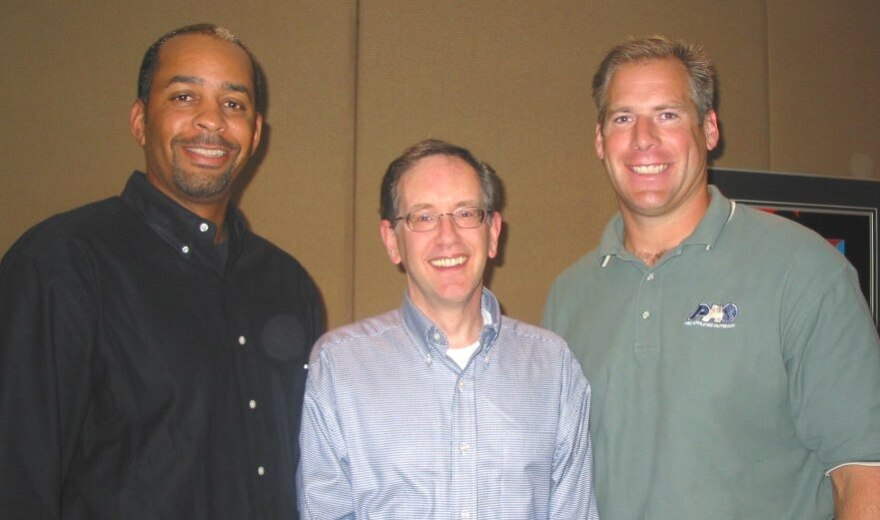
548,348 -> 599,520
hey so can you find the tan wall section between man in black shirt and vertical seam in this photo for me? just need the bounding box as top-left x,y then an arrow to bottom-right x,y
229,0 -> 357,327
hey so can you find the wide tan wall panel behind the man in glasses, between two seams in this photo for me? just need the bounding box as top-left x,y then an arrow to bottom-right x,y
355,0 -> 767,322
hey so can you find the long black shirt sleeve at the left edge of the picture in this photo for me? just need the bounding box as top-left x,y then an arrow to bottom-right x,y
0,243 -> 93,519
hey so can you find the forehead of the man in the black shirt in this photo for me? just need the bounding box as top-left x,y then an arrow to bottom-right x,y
153,34 -> 253,92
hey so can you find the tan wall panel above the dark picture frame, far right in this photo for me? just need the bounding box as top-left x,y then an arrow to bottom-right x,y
768,0 -> 880,179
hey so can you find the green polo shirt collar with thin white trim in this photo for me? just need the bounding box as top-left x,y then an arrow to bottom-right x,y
598,185 -> 736,265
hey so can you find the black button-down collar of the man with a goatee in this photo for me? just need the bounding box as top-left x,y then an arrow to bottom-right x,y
122,171 -> 246,275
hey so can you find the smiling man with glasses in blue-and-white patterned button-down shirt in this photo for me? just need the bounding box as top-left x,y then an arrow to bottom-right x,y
297,140 -> 598,520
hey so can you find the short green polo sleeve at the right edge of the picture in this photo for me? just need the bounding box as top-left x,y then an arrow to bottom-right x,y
782,258 -> 880,471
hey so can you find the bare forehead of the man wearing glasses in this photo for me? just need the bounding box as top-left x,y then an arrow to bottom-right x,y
398,155 -> 483,208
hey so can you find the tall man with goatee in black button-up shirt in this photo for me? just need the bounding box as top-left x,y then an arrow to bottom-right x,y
0,25 -> 324,520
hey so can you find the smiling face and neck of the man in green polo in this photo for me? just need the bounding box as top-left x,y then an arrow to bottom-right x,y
596,58 -> 719,230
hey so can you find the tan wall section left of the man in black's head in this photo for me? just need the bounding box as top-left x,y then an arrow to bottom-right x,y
0,1 -> 141,251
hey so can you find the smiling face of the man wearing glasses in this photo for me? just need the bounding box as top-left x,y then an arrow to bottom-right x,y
380,155 -> 501,319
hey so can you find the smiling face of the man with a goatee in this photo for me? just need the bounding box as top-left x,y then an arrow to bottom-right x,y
131,34 -> 262,221
